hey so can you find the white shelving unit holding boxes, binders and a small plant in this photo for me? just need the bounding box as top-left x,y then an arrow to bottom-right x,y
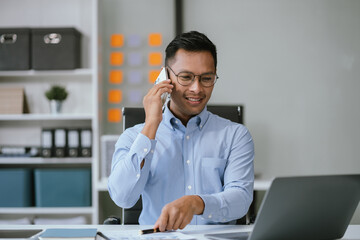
0,0 -> 99,224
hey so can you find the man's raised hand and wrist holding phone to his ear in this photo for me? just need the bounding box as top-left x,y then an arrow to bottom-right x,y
141,79 -> 174,139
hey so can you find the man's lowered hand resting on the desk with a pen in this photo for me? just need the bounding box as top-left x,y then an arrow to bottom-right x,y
154,195 -> 205,232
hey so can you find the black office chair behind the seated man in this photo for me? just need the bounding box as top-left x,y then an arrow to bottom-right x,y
104,105 -> 248,224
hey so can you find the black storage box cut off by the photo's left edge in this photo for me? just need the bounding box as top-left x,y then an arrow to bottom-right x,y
0,28 -> 31,70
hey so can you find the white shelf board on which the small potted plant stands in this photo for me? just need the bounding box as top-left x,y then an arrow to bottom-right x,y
0,113 -> 92,121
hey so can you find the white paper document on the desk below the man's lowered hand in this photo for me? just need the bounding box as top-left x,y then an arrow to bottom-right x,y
101,230 -> 195,240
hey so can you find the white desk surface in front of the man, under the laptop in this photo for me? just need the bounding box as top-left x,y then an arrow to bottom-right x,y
0,225 -> 360,240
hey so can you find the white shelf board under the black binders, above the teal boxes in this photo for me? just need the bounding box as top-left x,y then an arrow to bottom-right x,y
0,157 -> 92,165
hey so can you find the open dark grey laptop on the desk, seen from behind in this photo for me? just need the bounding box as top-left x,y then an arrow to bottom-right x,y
205,174 -> 360,240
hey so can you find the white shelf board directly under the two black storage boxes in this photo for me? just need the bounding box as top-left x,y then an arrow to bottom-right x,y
0,68 -> 92,79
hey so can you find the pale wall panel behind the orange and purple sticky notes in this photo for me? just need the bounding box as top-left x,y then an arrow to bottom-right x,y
100,0 -> 175,135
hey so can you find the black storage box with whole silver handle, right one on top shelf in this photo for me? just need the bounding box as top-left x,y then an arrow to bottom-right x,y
31,28 -> 81,70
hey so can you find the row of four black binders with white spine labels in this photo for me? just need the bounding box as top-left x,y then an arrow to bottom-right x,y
41,128 -> 92,158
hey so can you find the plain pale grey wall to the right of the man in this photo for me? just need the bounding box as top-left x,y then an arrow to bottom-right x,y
184,0 -> 360,177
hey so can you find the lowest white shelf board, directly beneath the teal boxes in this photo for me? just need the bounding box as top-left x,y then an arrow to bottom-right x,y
0,207 -> 93,215
